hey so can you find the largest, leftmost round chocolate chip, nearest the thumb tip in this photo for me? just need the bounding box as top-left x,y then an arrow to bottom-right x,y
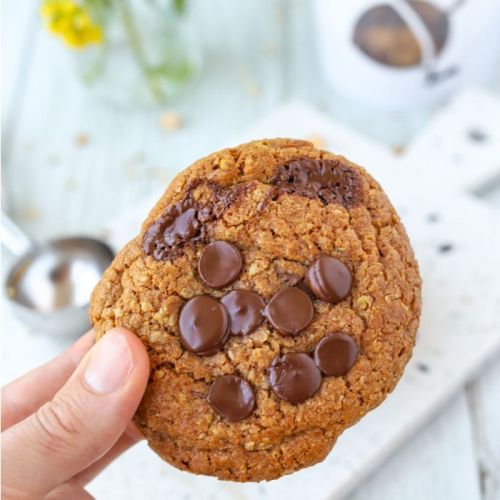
179,295 -> 230,356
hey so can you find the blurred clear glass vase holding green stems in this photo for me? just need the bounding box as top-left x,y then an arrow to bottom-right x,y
76,0 -> 201,106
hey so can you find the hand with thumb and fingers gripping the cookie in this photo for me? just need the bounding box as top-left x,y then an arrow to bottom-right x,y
1,328 -> 149,500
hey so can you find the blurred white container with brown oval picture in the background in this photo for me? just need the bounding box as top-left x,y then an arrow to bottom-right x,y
314,0 -> 500,111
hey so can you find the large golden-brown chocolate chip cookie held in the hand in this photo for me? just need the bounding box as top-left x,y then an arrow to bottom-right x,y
91,139 -> 421,481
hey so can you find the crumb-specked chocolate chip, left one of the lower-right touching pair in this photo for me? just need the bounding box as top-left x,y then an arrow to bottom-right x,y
269,352 -> 321,403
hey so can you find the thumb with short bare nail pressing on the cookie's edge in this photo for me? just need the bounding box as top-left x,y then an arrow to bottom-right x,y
2,328 -> 149,497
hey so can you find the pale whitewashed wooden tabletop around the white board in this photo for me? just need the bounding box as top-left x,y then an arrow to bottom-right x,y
1,0 -> 500,500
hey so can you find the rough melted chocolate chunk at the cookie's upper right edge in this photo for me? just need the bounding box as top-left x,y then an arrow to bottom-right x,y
272,158 -> 362,208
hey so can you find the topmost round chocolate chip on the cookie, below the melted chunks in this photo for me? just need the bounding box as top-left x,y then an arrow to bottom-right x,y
198,241 -> 243,288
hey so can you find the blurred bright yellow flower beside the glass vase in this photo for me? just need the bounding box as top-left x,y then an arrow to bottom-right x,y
40,0 -> 103,49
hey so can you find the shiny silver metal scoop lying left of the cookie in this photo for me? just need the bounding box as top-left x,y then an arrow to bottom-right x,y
0,212 -> 114,336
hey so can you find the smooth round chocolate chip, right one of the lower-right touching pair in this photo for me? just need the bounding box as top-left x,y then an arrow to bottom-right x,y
314,333 -> 358,377
